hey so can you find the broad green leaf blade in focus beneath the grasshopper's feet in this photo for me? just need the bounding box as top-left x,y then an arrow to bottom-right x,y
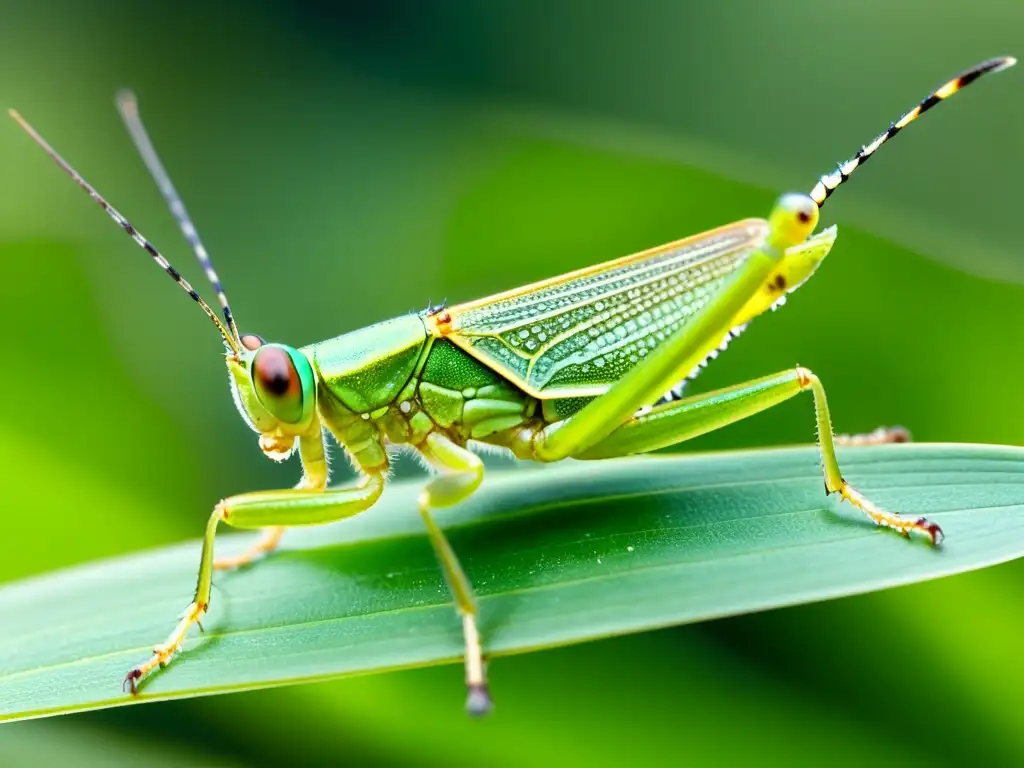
0,444 -> 1024,720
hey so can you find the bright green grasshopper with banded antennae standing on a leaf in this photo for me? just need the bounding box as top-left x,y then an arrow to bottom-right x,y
10,57 -> 1016,714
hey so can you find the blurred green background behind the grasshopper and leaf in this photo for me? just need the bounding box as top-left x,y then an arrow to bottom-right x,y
0,0 -> 1024,766
